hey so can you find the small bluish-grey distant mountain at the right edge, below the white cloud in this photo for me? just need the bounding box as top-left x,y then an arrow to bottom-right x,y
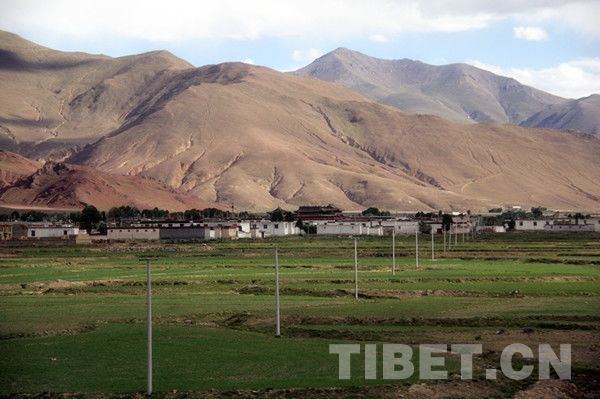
523,94 -> 600,136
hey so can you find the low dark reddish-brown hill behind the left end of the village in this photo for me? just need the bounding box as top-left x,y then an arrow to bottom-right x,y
0,158 -> 220,211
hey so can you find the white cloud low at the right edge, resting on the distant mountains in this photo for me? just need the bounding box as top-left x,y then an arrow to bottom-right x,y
469,58 -> 600,98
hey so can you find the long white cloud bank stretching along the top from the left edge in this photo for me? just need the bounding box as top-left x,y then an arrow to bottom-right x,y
0,0 -> 498,41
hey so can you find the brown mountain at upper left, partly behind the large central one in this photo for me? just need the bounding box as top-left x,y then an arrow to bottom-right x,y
0,31 -> 191,159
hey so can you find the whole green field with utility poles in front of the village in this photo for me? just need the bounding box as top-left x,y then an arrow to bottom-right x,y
0,233 -> 600,397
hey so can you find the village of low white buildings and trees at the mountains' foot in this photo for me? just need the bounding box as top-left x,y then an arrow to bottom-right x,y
0,205 -> 600,246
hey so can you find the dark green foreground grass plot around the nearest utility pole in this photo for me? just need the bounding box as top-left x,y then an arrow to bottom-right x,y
0,324 -> 428,392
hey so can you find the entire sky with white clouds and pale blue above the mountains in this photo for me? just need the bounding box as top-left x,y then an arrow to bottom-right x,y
0,0 -> 600,98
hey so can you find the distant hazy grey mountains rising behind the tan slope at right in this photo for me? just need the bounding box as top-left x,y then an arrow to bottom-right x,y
293,48 -> 600,134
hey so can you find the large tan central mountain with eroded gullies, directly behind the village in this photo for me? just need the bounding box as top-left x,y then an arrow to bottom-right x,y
71,63 -> 600,209
